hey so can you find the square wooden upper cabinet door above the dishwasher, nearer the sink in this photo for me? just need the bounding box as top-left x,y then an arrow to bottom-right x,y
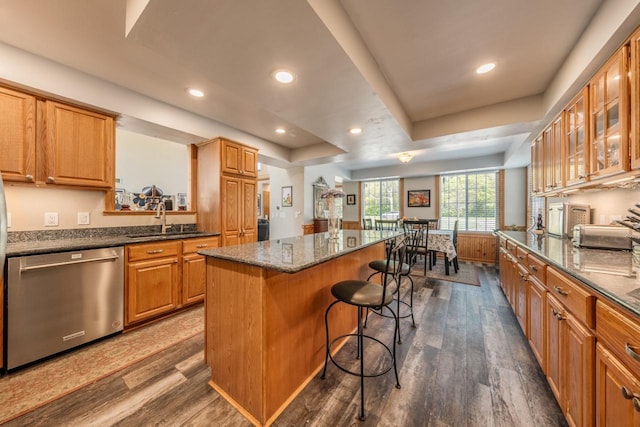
45,101 -> 115,188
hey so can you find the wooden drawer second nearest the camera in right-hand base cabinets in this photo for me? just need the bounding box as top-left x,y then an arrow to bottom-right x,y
546,268 -> 596,328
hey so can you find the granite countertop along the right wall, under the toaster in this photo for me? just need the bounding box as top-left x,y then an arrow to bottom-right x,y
497,231 -> 640,316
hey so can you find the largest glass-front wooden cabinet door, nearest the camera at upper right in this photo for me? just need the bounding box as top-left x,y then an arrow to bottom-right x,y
589,46 -> 630,177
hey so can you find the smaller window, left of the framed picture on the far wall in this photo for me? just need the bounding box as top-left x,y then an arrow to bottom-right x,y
362,179 -> 400,219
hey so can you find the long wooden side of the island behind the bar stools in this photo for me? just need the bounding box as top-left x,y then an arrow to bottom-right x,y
264,242 -> 384,421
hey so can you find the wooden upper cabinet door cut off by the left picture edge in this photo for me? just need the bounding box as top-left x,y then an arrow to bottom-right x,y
0,87 -> 36,182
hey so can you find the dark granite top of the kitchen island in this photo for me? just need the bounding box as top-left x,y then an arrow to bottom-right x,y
198,230 -> 402,273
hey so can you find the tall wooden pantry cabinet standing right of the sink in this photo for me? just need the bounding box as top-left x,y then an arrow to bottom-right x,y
197,138 -> 258,246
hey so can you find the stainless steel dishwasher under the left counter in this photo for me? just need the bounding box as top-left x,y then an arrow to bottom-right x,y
6,247 -> 124,369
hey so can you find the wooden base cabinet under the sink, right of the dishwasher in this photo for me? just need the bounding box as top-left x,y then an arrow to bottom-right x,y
125,237 -> 219,327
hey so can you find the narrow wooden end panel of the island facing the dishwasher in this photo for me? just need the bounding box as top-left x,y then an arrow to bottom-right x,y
205,257 -> 264,421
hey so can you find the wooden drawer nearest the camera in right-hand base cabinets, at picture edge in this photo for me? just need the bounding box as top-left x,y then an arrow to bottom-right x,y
596,301 -> 640,376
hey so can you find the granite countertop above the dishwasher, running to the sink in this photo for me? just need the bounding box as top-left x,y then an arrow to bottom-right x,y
7,227 -> 220,257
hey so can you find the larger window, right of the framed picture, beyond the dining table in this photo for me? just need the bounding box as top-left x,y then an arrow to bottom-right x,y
440,171 -> 498,231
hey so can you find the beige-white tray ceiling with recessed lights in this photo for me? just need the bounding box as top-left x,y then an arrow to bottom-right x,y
0,0 -> 636,176
